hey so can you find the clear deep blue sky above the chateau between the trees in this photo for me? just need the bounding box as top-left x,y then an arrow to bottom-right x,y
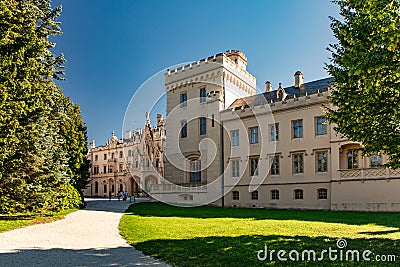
53,0 -> 338,145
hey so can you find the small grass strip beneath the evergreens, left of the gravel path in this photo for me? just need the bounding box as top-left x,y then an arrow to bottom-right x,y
0,209 -> 77,232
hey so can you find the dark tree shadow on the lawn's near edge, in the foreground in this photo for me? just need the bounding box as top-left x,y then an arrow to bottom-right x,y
135,235 -> 400,267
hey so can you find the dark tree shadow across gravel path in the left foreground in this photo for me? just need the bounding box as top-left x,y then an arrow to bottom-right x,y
0,247 -> 163,267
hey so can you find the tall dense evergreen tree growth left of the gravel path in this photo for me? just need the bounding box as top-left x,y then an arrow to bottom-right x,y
0,0 -> 87,213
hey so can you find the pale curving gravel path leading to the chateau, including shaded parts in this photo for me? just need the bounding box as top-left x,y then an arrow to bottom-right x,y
0,199 -> 168,267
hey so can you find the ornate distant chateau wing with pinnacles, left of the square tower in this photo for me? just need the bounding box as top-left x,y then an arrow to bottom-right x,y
83,113 -> 165,197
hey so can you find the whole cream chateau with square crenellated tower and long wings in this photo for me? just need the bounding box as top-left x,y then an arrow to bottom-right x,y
85,50 -> 400,211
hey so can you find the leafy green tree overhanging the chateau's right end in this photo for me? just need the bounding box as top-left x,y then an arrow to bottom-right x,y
325,0 -> 400,168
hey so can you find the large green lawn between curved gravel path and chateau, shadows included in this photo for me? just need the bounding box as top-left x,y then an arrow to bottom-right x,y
120,203 -> 400,266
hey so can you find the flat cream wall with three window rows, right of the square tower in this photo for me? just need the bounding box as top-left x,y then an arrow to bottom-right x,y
221,93 -> 332,209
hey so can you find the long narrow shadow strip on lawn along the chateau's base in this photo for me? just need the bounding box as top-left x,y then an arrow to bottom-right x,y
126,203 -> 400,231
